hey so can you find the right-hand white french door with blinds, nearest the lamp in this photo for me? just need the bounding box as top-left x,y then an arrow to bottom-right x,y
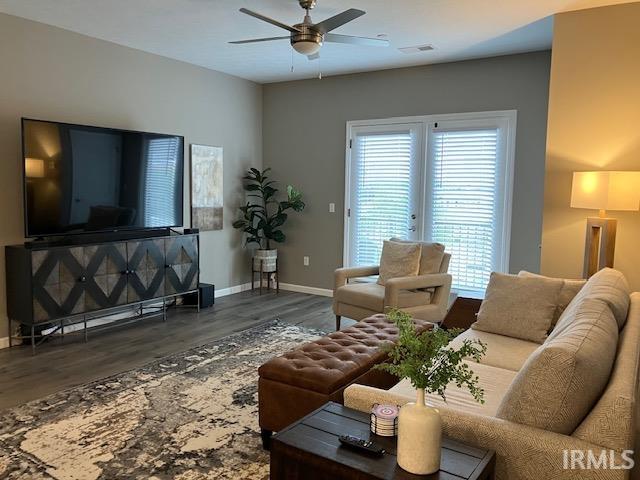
424,118 -> 511,296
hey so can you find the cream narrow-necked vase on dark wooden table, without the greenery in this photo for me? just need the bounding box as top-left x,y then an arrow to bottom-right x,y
398,389 -> 442,475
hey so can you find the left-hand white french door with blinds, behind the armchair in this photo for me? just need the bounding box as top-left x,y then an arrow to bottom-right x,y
345,123 -> 424,266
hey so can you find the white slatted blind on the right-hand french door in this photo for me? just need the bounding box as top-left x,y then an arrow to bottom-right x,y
431,129 -> 501,292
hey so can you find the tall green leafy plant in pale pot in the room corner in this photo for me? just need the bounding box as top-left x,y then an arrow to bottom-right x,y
233,168 -> 305,274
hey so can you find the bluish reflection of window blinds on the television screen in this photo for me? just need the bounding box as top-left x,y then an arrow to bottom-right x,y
144,137 -> 180,226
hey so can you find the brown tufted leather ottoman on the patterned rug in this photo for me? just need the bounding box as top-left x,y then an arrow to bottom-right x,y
258,315 -> 432,448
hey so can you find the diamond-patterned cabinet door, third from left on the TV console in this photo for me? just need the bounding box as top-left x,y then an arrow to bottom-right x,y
126,239 -> 165,303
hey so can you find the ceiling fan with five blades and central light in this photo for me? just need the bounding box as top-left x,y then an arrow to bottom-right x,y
229,0 -> 389,60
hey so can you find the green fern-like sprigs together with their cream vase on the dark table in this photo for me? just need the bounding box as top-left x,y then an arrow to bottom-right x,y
376,309 -> 487,475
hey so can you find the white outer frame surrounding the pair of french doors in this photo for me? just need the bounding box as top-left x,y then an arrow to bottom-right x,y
342,110 -> 518,298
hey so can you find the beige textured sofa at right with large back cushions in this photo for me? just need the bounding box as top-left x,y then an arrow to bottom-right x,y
344,269 -> 640,480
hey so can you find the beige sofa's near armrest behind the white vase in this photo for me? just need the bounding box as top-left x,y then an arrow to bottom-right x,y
344,385 -> 629,480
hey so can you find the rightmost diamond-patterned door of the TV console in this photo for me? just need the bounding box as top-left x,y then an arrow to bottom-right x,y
164,235 -> 199,295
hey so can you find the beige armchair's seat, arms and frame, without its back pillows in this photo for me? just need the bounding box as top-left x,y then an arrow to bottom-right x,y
333,253 -> 451,330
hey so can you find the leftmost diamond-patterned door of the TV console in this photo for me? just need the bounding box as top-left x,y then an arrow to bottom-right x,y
31,247 -> 86,322
